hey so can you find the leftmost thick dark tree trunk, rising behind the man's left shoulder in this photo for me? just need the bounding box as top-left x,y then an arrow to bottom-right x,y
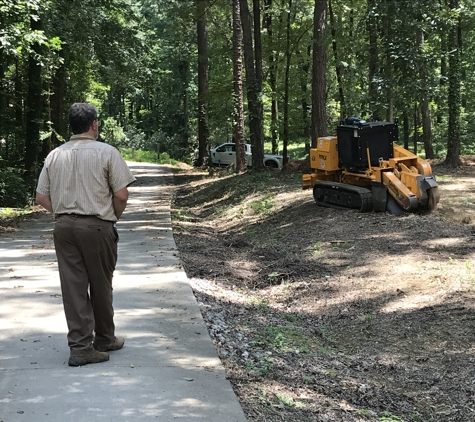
24,18 -> 43,181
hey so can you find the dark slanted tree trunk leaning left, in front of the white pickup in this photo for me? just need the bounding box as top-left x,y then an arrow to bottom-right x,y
239,0 -> 264,170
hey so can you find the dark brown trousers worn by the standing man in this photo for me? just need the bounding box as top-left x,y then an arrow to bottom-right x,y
54,215 -> 119,356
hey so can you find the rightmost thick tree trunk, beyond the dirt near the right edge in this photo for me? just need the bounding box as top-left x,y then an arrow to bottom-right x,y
445,0 -> 462,167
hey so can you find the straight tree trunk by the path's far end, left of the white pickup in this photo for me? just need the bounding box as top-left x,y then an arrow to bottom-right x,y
197,0 -> 209,166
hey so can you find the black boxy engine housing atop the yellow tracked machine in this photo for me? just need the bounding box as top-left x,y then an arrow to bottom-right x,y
337,117 -> 398,172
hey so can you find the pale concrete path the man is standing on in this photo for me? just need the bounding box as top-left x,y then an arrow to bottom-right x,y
0,163 -> 246,422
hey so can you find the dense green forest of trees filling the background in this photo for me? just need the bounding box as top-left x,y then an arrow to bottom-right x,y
0,0 -> 475,206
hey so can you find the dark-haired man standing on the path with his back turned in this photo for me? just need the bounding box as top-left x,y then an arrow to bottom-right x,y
36,103 -> 135,366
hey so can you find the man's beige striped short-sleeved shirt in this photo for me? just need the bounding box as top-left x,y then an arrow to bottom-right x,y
36,135 -> 136,221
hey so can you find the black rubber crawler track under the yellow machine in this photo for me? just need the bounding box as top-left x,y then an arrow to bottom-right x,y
313,182 -> 373,212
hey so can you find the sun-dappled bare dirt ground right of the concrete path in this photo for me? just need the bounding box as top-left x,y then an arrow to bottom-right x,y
172,157 -> 475,422
